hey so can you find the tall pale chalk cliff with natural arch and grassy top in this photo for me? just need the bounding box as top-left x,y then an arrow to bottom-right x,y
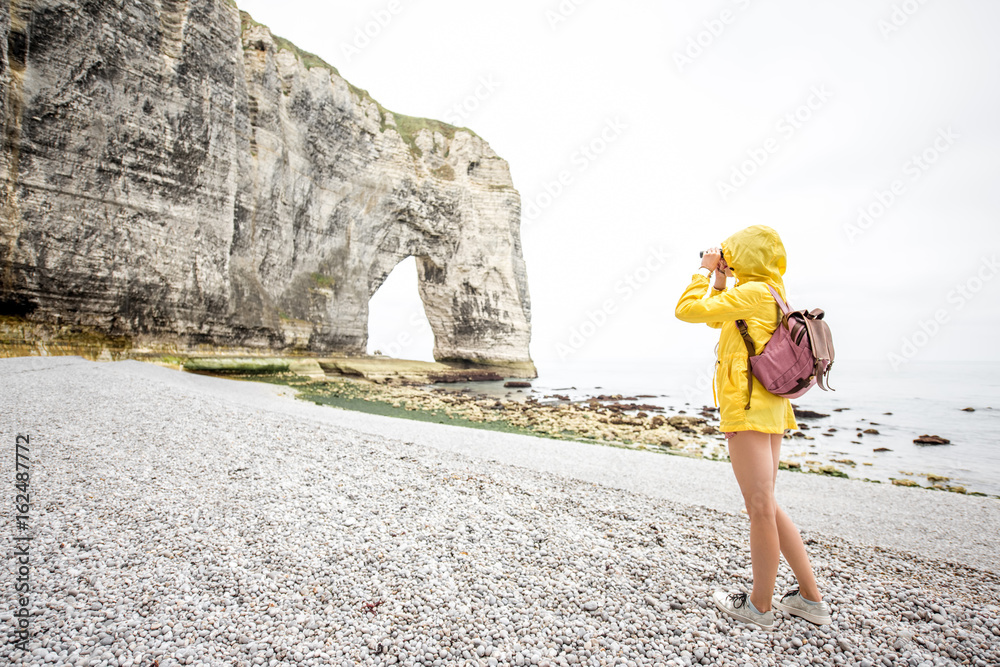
0,0 -> 533,371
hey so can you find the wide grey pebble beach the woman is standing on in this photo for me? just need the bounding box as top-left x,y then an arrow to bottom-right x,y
0,357 -> 1000,667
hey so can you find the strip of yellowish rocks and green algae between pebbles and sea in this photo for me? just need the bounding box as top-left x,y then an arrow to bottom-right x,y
191,368 -> 986,496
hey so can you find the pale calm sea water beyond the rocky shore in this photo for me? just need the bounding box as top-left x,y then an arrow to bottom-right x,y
469,358 -> 1000,496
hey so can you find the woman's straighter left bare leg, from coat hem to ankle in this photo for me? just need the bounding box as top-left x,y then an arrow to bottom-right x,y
729,431 -> 780,612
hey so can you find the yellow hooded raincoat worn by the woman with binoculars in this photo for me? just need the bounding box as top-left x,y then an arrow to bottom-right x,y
674,225 -> 798,433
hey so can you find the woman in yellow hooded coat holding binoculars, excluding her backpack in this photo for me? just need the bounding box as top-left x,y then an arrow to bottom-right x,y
675,225 -> 830,629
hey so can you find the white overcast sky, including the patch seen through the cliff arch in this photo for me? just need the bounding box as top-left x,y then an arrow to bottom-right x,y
237,0 -> 1000,368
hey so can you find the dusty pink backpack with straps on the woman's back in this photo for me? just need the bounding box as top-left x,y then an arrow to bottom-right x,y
736,285 -> 833,410
